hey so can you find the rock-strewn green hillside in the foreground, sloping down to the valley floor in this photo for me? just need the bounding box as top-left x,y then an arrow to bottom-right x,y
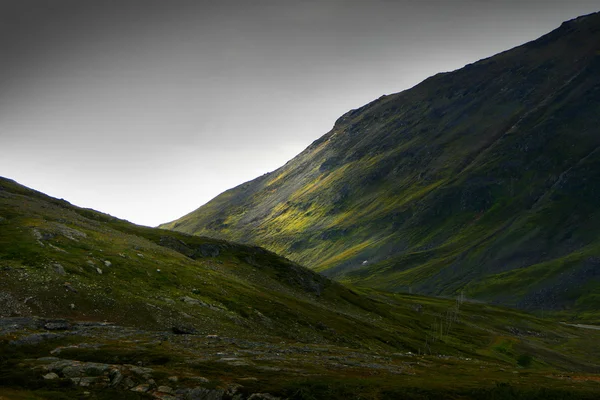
0,178 -> 600,400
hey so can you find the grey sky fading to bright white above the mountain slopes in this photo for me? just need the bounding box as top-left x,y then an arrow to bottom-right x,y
0,0 -> 600,226
